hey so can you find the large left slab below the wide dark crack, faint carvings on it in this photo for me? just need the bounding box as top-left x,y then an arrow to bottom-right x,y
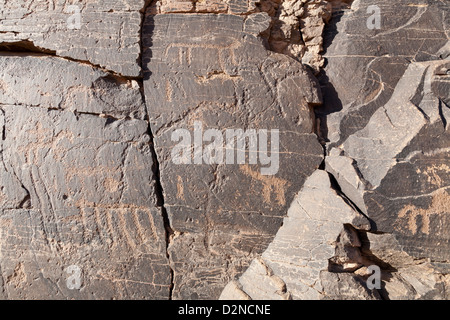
0,55 -> 171,299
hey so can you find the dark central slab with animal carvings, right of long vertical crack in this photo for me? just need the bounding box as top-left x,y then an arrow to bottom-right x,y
143,13 -> 323,298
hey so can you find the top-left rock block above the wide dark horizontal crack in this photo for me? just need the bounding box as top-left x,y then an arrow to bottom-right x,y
0,0 -> 145,77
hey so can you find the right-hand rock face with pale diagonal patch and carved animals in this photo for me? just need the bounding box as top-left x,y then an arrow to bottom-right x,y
318,0 -> 450,298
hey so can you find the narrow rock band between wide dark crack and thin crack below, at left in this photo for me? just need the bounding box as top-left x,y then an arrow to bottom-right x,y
0,53 -> 146,120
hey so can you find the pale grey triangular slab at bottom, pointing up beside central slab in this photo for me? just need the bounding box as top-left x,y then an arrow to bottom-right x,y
221,170 -> 377,300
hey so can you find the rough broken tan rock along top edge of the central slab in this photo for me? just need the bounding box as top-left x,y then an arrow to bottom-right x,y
150,0 -> 332,72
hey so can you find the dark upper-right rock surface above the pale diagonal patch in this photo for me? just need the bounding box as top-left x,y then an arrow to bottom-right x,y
321,0 -> 449,143
